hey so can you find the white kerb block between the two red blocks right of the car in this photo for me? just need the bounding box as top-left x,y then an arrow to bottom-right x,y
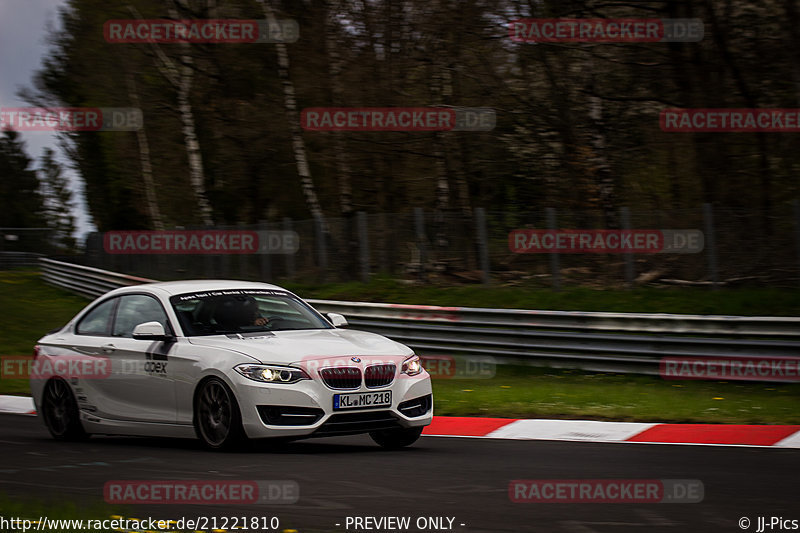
486,420 -> 657,442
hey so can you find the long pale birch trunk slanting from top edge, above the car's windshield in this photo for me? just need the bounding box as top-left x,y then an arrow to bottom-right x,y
257,0 -> 328,222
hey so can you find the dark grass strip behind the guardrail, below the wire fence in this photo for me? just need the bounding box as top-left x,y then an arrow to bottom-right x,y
283,277 -> 800,316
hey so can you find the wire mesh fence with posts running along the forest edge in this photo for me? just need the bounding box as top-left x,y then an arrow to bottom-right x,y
29,202 -> 800,289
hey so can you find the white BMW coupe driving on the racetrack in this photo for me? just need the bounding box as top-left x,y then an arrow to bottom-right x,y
31,280 -> 433,449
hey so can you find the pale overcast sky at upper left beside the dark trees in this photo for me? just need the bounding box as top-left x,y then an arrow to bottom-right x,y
0,0 -> 94,237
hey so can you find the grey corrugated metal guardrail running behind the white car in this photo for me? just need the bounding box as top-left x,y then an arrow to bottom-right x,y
41,259 -> 800,374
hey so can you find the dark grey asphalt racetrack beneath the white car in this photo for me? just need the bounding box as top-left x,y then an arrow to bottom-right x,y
0,415 -> 800,533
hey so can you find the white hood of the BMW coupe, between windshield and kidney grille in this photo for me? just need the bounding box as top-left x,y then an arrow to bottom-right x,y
189,329 -> 413,364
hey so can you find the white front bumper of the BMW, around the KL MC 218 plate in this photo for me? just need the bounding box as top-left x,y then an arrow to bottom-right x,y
231,372 -> 433,438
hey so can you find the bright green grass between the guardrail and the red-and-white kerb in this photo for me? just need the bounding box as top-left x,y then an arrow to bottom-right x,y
433,366 -> 800,424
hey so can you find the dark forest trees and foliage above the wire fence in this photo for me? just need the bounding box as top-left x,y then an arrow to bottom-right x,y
23,0 -> 800,231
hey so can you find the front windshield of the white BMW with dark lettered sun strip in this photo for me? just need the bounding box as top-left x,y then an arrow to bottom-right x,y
170,289 -> 333,337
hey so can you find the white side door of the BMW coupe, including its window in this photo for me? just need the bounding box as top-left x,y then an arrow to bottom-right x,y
99,294 -> 176,423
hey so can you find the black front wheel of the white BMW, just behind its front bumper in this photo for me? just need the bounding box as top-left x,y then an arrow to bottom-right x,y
194,378 -> 247,450
